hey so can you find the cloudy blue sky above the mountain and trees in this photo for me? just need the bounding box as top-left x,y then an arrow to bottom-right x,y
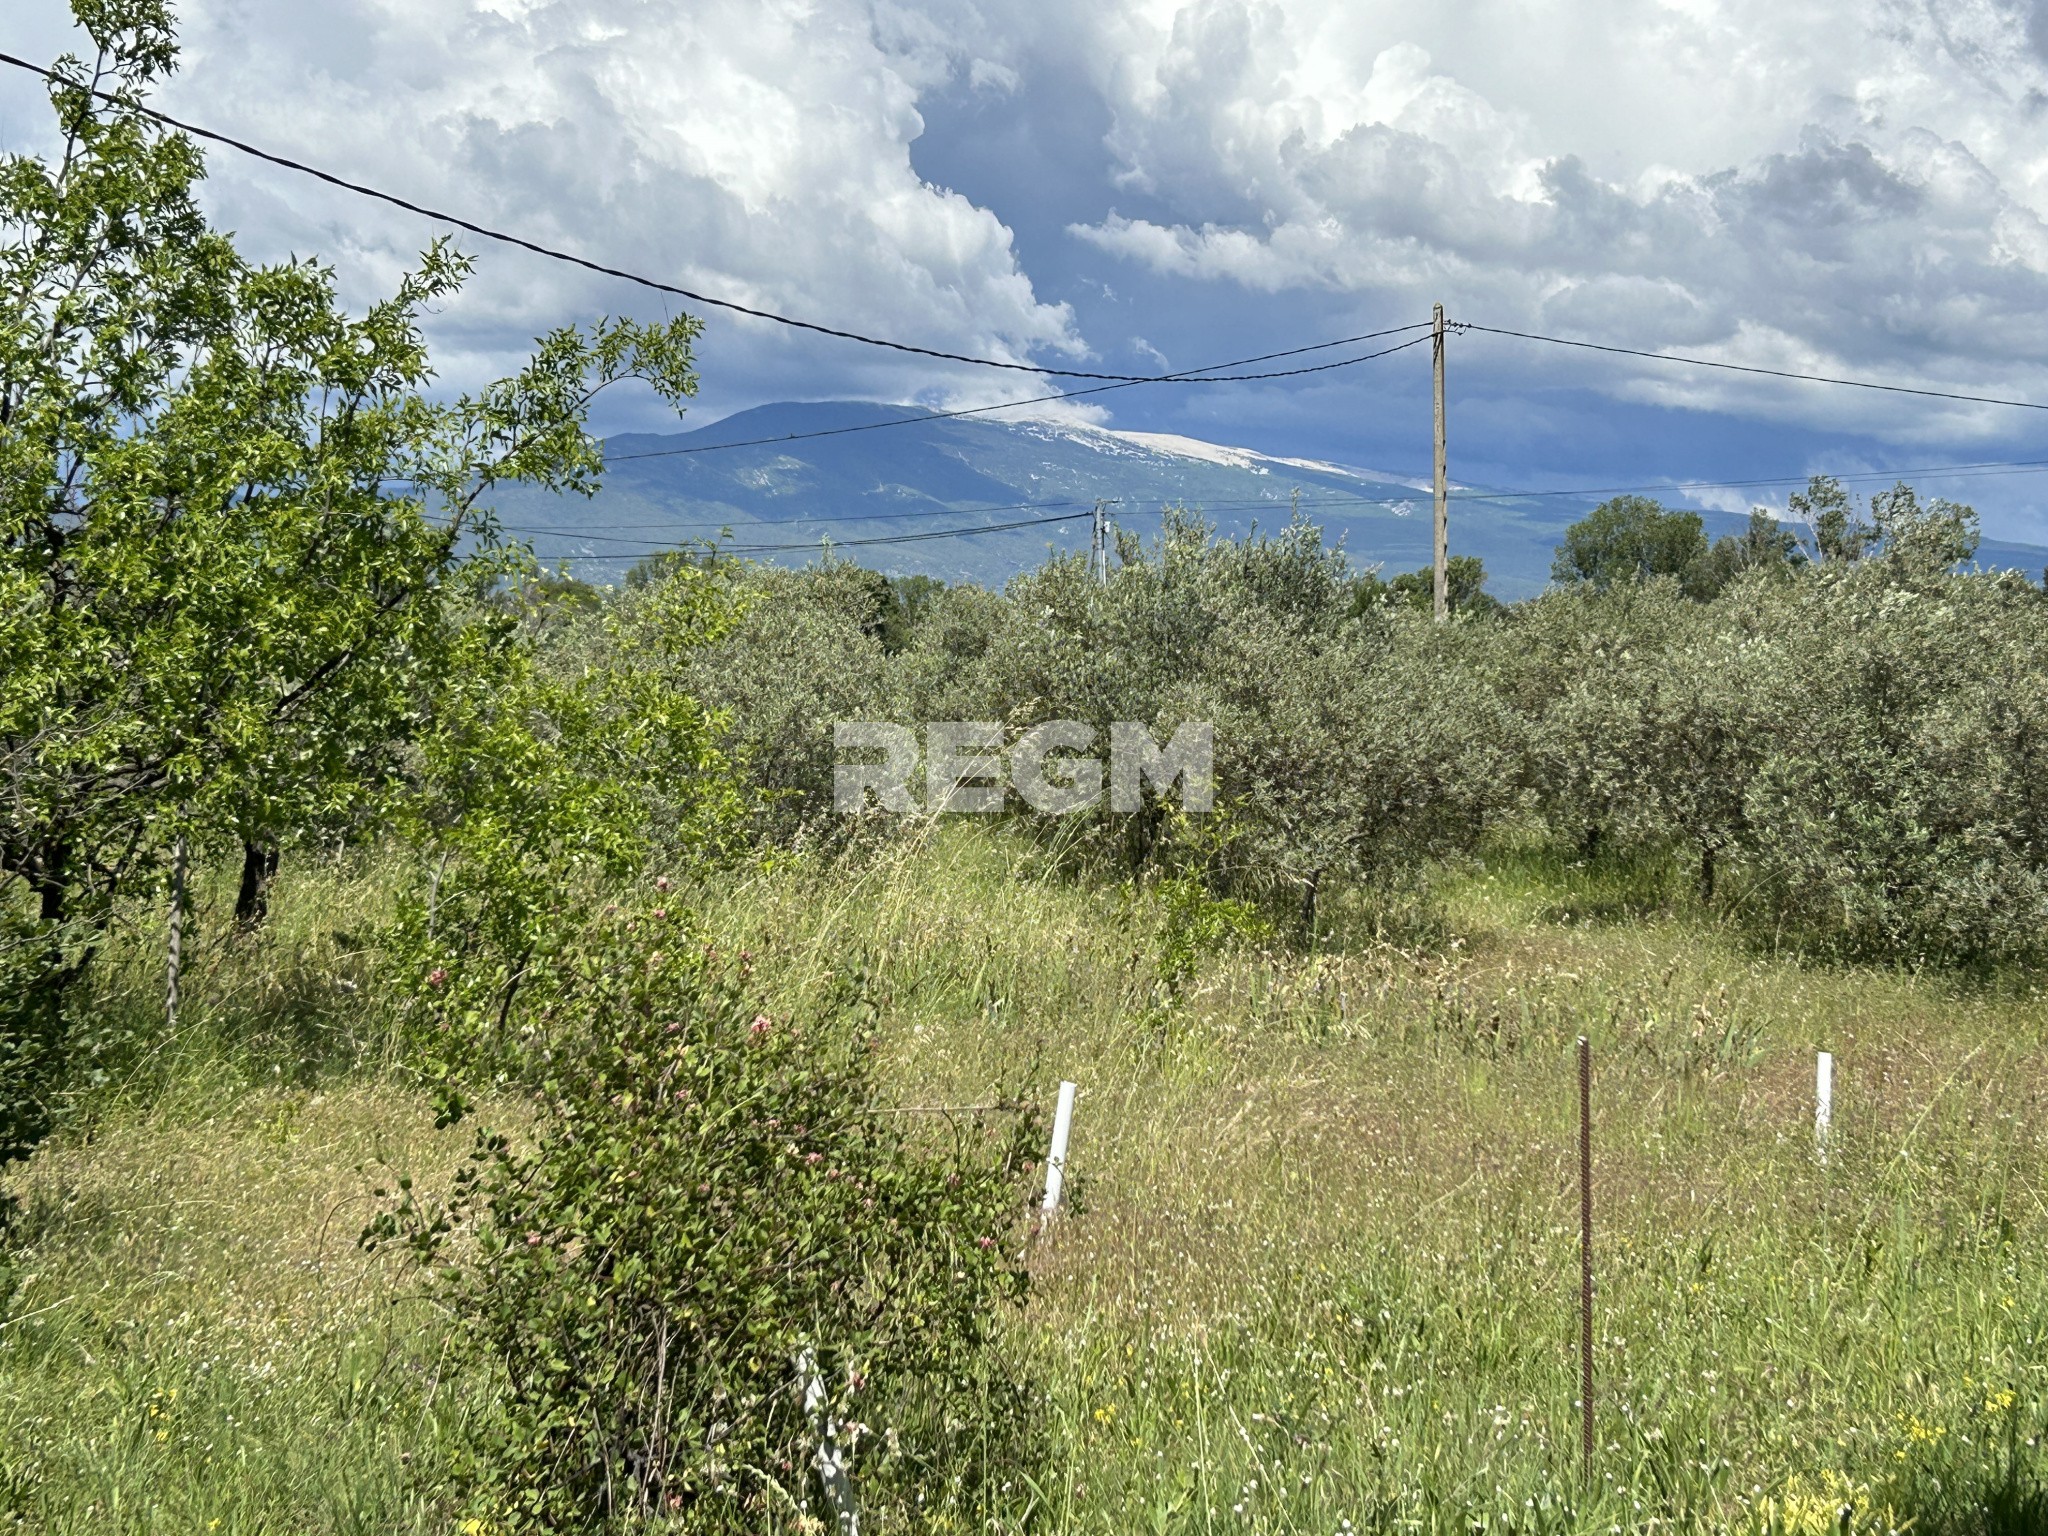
0,0 -> 2048,543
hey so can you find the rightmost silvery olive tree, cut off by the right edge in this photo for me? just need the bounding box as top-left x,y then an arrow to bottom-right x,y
1745,552 -> 2048,961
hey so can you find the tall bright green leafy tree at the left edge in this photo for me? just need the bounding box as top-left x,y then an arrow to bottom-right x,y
0,0 -> 696,1159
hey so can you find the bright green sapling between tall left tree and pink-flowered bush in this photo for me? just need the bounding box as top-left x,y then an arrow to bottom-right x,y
383,567 -> 750,1114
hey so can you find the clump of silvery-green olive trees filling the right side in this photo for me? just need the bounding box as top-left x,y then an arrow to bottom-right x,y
1503,483 -> 2048,965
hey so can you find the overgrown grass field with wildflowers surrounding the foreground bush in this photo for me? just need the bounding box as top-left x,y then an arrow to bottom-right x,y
0,831 -> 2048,1536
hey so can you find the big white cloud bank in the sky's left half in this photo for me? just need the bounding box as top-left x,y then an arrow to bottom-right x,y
8,0 -> 1085,421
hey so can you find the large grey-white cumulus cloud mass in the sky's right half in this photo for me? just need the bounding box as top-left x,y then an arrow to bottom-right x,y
1073,0 -> 2048,444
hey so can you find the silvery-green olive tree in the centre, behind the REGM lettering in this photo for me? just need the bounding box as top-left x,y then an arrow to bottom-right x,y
905,510 -> 1513,913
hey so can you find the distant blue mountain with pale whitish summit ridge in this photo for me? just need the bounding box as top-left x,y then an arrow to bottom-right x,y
496,401 -> 2048,600
